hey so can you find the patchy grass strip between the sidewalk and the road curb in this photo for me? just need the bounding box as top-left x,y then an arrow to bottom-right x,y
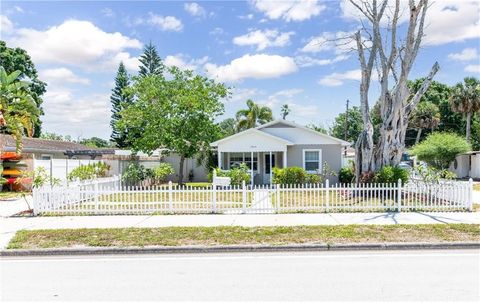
7,224 -> 480,249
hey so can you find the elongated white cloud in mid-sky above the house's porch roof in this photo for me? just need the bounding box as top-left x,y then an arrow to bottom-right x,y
205,54 -> 298,82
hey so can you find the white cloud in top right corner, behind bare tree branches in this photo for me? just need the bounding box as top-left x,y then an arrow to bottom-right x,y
340,0 -> 480,45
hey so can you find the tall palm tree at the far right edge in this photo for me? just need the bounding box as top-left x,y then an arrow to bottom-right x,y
450,77 -> 480,141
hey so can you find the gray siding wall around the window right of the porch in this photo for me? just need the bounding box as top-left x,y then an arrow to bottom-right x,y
287,145 -> 343,182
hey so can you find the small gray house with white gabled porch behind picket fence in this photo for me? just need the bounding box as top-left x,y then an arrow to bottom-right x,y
210,120 -> 350,184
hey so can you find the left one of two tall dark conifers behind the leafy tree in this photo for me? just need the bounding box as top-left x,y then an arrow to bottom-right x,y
110,62 -> 133,148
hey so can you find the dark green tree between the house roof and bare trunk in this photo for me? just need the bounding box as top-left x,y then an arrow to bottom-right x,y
332,106 -> 363,142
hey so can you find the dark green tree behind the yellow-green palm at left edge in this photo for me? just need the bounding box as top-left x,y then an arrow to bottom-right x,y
0,41 -> 47,137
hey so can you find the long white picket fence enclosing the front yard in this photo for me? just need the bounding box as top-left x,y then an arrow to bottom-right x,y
33,177 -> 473,215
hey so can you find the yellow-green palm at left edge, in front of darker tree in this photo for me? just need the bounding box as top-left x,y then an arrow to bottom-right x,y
0,66 -> 40,152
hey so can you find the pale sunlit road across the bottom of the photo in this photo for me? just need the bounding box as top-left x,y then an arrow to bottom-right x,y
0,250 -> 480,301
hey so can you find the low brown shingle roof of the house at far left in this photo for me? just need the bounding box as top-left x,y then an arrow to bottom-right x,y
0,134 -> 97,153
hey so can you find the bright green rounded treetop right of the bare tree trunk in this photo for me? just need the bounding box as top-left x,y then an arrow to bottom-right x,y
411,132 -> 471,169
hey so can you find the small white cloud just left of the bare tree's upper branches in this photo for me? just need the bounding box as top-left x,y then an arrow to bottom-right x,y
300,31 -> 356,54
